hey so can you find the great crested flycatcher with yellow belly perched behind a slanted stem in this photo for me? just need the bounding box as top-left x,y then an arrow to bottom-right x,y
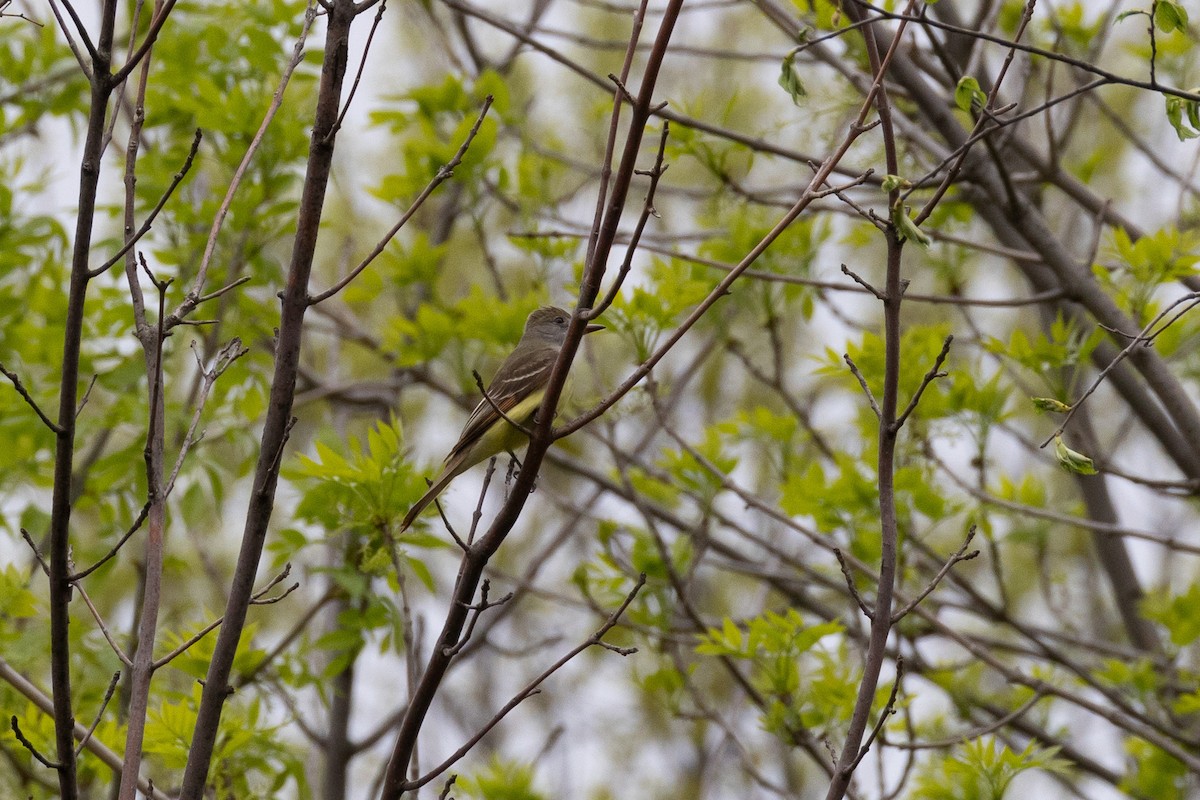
400,306 -> 604,533
